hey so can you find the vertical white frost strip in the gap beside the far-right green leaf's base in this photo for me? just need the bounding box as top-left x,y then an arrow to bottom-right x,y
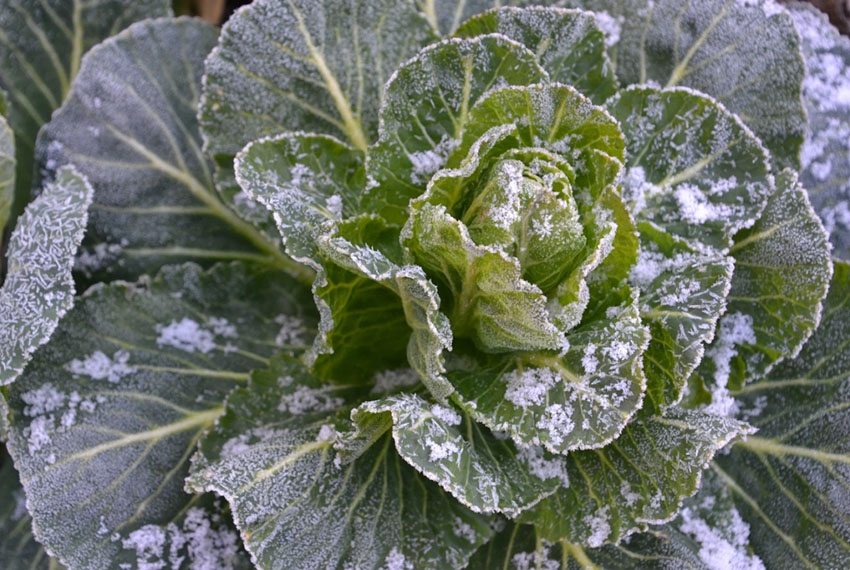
704,313 -> 756,416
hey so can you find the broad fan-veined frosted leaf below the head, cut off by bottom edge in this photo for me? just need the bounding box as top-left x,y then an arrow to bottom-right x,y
187,360 -> 491,570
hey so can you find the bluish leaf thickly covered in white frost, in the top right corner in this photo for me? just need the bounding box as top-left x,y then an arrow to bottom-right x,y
790,2 -> 850,259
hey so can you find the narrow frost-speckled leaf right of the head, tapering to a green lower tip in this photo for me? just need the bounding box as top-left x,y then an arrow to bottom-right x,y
630,222 -> 735,410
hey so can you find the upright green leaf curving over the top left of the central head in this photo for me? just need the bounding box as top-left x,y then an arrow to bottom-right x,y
364,35 -> 548,225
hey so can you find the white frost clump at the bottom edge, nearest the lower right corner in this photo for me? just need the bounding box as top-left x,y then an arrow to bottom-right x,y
679,496 -> 765,570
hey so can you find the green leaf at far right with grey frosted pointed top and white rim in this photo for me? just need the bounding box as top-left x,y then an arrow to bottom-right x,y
720,170 -> 832,386
